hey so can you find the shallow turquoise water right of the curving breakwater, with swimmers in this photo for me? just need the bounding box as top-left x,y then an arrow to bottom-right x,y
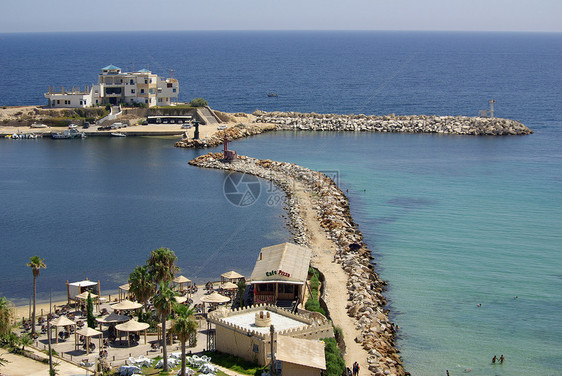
233,132 -> 562,375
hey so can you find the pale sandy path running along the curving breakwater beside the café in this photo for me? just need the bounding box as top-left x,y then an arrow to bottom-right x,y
295,183 -> 368,374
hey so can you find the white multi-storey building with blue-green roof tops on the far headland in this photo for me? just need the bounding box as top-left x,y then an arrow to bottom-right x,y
45,65 -> 179,107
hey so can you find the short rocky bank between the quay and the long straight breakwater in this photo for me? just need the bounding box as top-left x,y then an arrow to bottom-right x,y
175,124 -> 277,149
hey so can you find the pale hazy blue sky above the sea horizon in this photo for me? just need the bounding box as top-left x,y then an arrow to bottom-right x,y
0,0 -> 562,33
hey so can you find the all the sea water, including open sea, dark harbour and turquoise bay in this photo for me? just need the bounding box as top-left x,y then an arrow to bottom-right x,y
0,31 -> 562,376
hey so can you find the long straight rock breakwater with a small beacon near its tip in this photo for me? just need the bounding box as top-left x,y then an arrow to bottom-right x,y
253,110 -> 533,136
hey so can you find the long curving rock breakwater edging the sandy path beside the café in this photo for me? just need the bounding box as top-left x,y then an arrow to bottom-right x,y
189,153 -> 406,376
